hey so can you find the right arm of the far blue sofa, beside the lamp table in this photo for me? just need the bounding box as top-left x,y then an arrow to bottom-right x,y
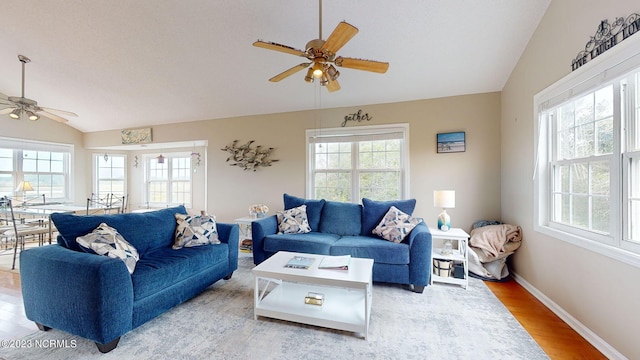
409,222 -> 432,286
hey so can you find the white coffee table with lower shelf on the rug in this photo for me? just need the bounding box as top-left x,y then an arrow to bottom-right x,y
252,251 -> 373,340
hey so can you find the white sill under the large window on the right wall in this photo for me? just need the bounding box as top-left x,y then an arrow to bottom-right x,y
534,225 -> 640,268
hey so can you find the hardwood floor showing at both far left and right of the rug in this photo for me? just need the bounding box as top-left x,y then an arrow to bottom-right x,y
0,270 -> 606,360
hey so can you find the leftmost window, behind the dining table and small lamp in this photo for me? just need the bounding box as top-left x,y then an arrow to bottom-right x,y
0,138 -> 73,202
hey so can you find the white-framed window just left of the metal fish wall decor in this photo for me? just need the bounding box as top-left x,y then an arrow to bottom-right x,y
147,153 -> 191,207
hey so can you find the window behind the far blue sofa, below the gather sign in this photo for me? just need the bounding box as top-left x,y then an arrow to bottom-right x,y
307,125 -> 408,203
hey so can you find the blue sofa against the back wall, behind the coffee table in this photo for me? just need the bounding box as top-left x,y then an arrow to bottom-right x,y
251,194 -> 431,293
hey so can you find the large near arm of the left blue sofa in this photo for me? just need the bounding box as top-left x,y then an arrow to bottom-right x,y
20,244 -> 133,344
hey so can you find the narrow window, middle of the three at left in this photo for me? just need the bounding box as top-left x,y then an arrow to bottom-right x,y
93,154 -> 127,198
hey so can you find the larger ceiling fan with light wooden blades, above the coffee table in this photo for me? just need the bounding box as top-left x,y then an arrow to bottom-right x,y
253,0 -> 389,92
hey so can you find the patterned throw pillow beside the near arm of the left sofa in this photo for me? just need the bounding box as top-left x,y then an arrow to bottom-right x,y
76,223 -> 140,274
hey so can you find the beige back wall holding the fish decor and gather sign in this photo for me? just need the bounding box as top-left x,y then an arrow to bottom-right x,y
85,93 -> 500,230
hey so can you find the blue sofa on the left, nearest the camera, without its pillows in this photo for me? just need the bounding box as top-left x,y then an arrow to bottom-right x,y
20,206 -> 238,353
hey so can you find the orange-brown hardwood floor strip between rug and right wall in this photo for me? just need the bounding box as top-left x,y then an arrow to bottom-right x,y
485,279 -> 606,360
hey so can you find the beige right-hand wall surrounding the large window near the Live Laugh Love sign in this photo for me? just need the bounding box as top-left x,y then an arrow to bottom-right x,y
501,0 -> 640,359
